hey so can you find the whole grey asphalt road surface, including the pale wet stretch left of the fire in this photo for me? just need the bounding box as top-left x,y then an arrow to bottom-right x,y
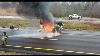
0,29 -> 100,54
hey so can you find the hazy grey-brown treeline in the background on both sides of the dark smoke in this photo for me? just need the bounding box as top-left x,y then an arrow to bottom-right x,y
0,2 -> 100,18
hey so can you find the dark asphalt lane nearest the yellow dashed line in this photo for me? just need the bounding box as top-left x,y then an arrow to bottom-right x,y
6,37 -> 100,53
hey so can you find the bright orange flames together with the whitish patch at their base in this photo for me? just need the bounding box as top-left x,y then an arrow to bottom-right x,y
40,20 -> 60,38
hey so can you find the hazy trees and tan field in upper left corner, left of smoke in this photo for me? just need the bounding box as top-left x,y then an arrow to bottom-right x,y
0,2 -> 18,16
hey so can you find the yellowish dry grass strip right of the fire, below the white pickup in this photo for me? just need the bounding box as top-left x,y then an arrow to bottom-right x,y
63,22 -> 100,31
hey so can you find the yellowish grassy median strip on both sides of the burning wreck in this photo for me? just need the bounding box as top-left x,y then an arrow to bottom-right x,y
0,19 -> 100,31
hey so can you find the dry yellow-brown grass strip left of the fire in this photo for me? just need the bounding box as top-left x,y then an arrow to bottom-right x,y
0,19 -> 38,27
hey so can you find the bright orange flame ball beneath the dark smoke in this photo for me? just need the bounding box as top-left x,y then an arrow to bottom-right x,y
42,20 -> 54,32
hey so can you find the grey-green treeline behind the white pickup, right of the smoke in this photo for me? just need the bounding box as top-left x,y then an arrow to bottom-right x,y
50,2 -> 100,18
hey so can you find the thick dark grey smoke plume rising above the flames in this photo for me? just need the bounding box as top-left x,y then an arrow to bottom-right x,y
16,2 -> 54,23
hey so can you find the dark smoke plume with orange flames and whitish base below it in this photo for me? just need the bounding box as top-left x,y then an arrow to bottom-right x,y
16,2 -> 60,38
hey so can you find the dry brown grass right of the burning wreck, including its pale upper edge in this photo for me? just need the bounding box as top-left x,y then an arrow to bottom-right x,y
63,19 -> 100,31
